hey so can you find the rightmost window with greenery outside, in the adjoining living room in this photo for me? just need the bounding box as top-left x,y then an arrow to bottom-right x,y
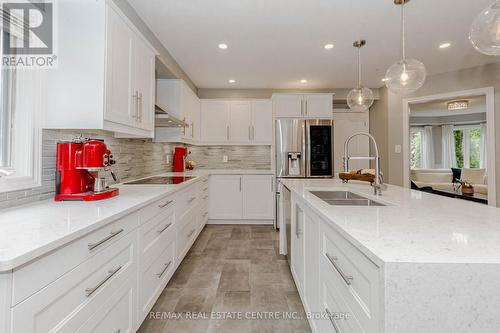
453,126 -> 483,168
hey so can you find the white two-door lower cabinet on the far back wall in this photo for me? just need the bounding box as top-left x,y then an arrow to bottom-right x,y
208,175 -> 274,223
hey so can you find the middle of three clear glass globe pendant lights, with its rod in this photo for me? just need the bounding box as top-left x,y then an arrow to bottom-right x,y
384,0 -> 427,95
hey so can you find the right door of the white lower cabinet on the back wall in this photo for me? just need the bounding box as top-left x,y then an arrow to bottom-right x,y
242,175 -> 274,220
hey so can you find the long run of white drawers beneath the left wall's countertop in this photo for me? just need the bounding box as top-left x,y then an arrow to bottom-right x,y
6,177 -> 208,333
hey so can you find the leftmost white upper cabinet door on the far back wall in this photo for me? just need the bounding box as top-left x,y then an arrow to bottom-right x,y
201,100 -> 229,142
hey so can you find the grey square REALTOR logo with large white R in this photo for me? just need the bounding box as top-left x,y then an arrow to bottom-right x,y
1,0 -> 57,68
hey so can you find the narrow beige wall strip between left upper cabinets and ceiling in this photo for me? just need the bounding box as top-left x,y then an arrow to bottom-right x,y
113,0 -> 198,93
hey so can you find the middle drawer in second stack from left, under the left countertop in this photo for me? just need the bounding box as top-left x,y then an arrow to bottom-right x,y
139,204 -> 175,266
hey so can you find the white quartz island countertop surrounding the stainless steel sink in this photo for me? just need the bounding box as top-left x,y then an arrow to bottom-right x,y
281,179 -> 500,264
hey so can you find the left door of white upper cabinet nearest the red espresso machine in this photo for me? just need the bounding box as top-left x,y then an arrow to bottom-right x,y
104,8 -> 137,126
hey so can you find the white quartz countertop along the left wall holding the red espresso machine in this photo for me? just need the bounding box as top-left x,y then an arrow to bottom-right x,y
0,170 -> 272,272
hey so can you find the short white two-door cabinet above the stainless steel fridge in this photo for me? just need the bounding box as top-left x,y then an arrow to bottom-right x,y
273,94 -> 333,119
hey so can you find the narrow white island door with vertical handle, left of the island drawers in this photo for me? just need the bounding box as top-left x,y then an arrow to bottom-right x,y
290,199 -> 305,297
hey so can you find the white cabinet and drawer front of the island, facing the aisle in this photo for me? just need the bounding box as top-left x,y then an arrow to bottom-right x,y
290,194 -> 381,333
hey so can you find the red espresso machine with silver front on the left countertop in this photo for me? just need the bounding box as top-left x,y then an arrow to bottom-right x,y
55,139 -> 118,201
